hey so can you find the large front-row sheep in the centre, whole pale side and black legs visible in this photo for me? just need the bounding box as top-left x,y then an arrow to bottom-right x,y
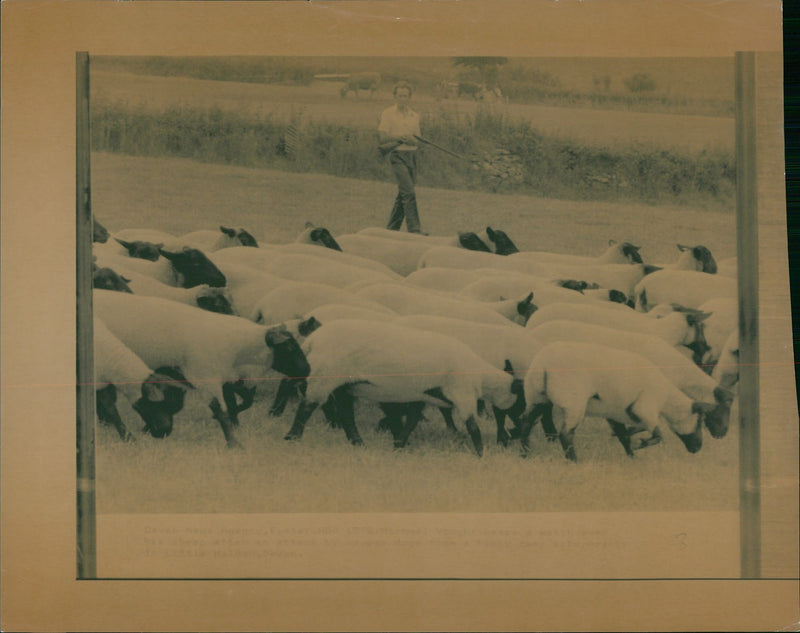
285,320 -> 521,456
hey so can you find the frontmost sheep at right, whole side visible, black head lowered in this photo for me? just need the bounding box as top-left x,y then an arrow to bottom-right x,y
519,341 -> 711,462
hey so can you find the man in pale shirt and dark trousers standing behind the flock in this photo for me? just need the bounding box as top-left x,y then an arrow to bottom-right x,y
378,81 -> 422,233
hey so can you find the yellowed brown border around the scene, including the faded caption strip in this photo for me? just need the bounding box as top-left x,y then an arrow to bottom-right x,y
1,0 -> 800,631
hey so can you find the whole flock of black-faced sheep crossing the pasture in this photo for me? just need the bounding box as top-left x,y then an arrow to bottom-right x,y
93,221 -> 738,461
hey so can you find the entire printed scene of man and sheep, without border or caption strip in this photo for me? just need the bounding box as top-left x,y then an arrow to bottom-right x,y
89,56 -> 752,575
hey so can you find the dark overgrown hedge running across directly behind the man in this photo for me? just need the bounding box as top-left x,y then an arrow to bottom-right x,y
92,101 -> 735,207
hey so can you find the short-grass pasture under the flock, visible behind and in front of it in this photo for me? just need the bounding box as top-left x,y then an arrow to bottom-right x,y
92,153 -> 738,513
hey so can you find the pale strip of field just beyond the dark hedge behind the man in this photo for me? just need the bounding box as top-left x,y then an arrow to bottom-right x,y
92,71 -> 734,152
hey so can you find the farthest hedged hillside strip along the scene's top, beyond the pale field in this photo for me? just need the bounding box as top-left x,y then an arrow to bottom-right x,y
92,56 -> 733,116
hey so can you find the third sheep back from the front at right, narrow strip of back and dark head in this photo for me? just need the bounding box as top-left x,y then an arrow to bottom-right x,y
526,302 -> 710,364
